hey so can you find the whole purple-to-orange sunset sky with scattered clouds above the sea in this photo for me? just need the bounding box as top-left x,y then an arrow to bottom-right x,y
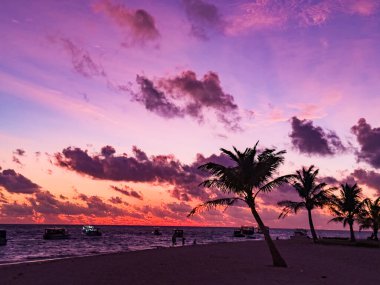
0,0 -> 380,229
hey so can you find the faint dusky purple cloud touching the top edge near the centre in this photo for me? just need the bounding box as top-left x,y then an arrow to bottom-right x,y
182,0 -> 225,40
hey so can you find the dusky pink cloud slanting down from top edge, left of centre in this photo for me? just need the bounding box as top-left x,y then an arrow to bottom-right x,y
93,0 -> 160,46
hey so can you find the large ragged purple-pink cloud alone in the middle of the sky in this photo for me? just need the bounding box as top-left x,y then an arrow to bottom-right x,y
130,70 -> 241,131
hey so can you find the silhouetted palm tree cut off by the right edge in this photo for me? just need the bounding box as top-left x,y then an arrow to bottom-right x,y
358,197 -> 380,240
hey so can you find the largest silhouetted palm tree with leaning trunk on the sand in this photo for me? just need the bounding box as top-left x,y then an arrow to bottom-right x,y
188,142 -> 293,267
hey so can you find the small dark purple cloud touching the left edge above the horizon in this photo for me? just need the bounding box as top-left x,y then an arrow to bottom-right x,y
0,169 -> 40,194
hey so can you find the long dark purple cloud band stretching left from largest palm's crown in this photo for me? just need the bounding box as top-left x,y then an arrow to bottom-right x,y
55,147 -> 231,201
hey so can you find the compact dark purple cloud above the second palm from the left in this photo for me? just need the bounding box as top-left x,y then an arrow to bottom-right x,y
289,117 -> 346,156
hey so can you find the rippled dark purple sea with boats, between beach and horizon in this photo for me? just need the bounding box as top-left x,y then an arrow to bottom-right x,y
0,225 -> 370,263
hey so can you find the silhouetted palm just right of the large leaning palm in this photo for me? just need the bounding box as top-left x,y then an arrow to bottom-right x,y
277,165 -> 331,242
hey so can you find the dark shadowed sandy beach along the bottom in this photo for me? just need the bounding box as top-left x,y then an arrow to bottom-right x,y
0,240 -> 380,285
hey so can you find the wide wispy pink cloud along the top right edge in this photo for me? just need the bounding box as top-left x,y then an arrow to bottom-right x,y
226,0 -> 380,35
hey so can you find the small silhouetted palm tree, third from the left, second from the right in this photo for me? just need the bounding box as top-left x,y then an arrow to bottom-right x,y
329,183 -> 363,242
